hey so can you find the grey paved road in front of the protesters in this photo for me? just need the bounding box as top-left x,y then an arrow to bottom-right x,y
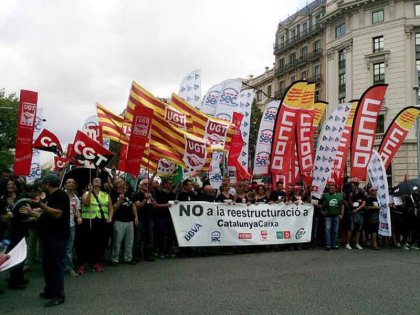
0,249 -> 420,315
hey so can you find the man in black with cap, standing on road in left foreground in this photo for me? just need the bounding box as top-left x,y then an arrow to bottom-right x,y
20,174 -> 70,307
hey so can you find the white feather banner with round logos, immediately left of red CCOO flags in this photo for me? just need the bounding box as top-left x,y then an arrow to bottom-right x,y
254,101 -> 280,175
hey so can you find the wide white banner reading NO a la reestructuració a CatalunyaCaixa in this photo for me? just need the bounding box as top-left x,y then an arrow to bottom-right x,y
170,202 -> 314,247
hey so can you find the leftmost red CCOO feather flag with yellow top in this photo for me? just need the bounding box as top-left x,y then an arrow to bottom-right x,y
270,81 -> 308,187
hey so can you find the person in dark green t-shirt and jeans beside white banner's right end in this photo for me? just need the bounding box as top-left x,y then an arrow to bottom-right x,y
321,183 -> 344,250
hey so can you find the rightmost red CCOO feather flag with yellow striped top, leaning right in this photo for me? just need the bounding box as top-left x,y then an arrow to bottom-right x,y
378,106 -> 420,169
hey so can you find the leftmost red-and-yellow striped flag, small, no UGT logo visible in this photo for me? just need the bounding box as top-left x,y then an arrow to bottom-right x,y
96,103 -> 129,144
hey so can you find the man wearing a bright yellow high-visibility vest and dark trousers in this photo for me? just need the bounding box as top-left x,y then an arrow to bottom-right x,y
78,177 -> 114,275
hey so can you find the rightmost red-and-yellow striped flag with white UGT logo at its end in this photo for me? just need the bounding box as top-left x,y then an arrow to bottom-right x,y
171,94 -> 236,150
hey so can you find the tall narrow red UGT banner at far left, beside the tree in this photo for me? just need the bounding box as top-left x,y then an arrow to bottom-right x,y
14,90 -> 38,176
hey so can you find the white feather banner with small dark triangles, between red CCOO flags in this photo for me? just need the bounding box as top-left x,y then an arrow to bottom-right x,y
312,103 -> 351,198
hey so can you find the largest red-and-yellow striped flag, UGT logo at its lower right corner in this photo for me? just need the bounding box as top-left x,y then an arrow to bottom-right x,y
124,82 -> 211,173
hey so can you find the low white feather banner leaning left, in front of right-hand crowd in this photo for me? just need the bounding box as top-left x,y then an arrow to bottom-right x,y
368,150 -> 391,236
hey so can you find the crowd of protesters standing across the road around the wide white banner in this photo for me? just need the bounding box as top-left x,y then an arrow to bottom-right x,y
0,170 -> 420,306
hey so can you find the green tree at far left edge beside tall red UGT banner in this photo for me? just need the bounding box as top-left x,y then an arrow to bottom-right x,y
0,89 -> 19,169
